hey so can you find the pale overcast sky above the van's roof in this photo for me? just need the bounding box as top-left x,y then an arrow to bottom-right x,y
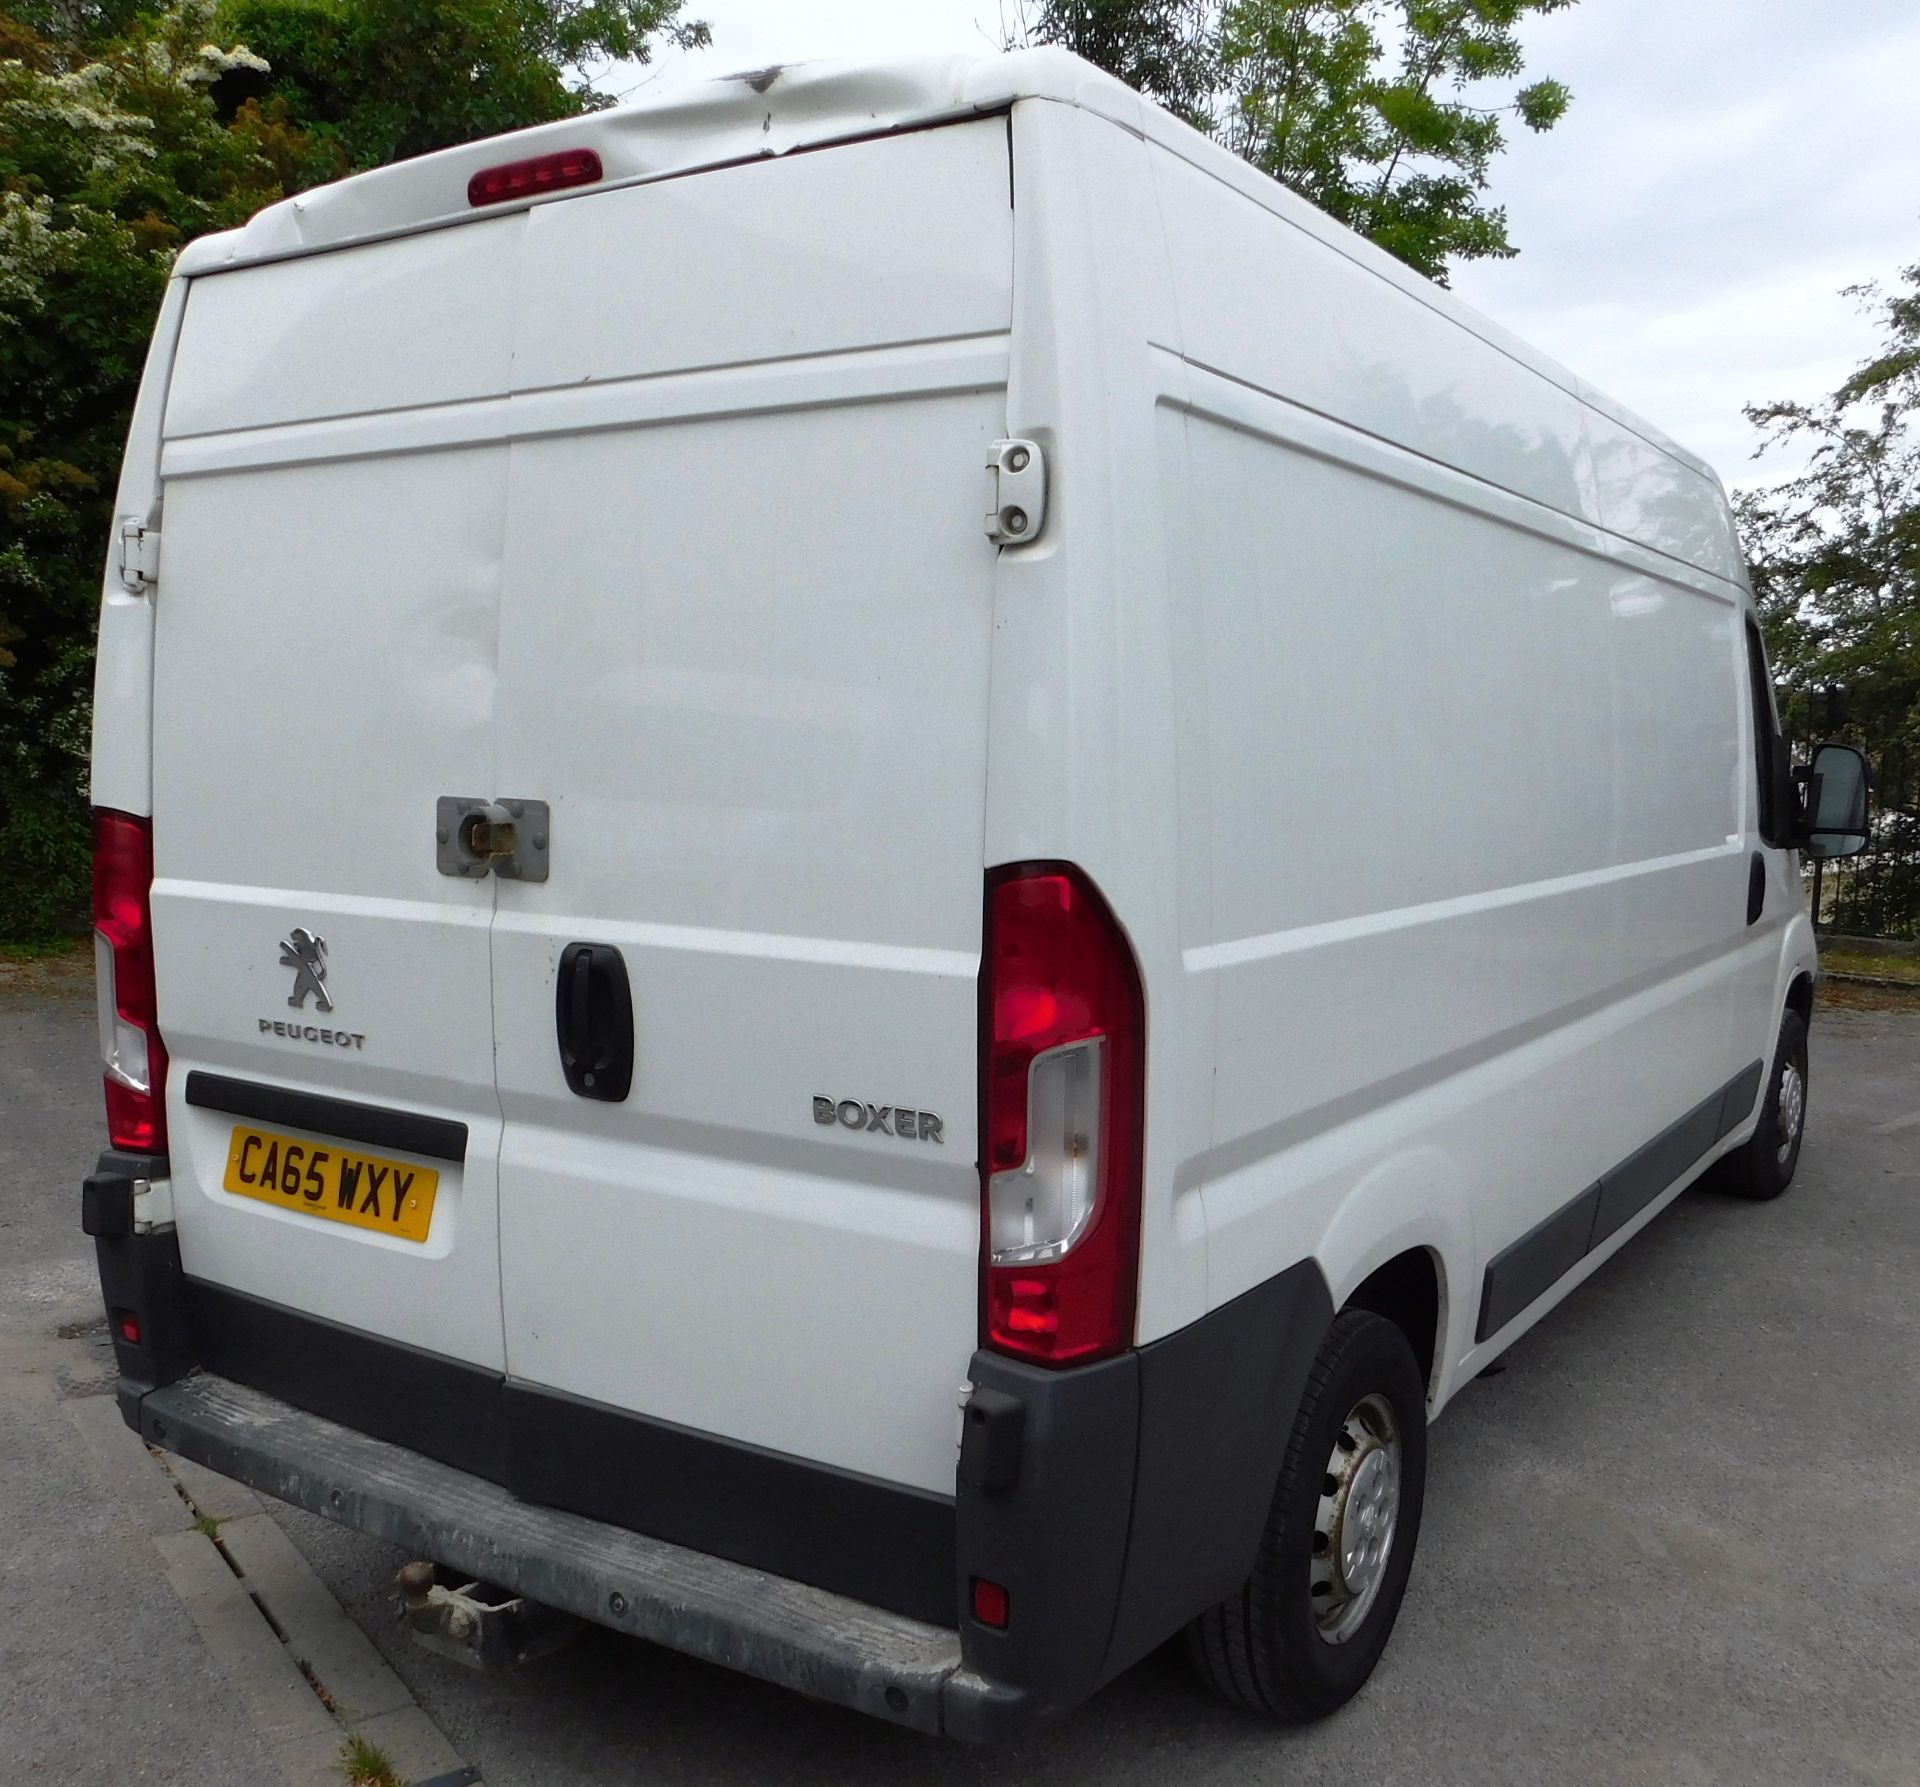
609,0 -> 1920,484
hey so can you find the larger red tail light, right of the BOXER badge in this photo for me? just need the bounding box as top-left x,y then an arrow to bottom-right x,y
981,868 -> 1146,1365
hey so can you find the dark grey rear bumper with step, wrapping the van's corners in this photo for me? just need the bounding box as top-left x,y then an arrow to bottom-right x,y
97,1182 -> 1332,1743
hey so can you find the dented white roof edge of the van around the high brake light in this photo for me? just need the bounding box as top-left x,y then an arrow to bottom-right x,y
177,48 -> 1718,486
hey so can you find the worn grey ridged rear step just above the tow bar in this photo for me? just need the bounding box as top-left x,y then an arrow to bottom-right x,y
140,1372 -> 1006,1737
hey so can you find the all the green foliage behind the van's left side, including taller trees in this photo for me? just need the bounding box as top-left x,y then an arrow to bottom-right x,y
0,0 -> 707,941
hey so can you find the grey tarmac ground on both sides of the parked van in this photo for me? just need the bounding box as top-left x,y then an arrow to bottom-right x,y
0,975 -> 1920,1787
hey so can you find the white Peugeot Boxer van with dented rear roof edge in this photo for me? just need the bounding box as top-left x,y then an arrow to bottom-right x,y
86,52 -> 1864,1739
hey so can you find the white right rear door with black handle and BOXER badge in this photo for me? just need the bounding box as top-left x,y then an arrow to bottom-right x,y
493,119 -> 1012,1493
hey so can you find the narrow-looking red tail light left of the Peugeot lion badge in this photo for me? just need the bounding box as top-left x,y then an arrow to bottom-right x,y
94,810 -> 167,1154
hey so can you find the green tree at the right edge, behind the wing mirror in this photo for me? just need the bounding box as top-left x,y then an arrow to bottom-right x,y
1736,263 -> 1920,935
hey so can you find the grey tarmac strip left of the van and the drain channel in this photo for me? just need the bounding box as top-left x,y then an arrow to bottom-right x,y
0,958 -> 273,1787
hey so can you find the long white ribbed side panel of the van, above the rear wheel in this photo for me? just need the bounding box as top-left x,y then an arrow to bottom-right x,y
1158,146 -> 1749,1389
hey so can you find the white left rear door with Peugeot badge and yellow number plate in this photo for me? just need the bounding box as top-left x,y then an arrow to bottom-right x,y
154,217 -> 524,1366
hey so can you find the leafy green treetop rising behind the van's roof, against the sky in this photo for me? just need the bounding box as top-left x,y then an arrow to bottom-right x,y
1012,0 -> 1574,284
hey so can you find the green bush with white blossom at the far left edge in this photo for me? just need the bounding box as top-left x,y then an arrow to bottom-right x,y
0,4 -> 311,937
